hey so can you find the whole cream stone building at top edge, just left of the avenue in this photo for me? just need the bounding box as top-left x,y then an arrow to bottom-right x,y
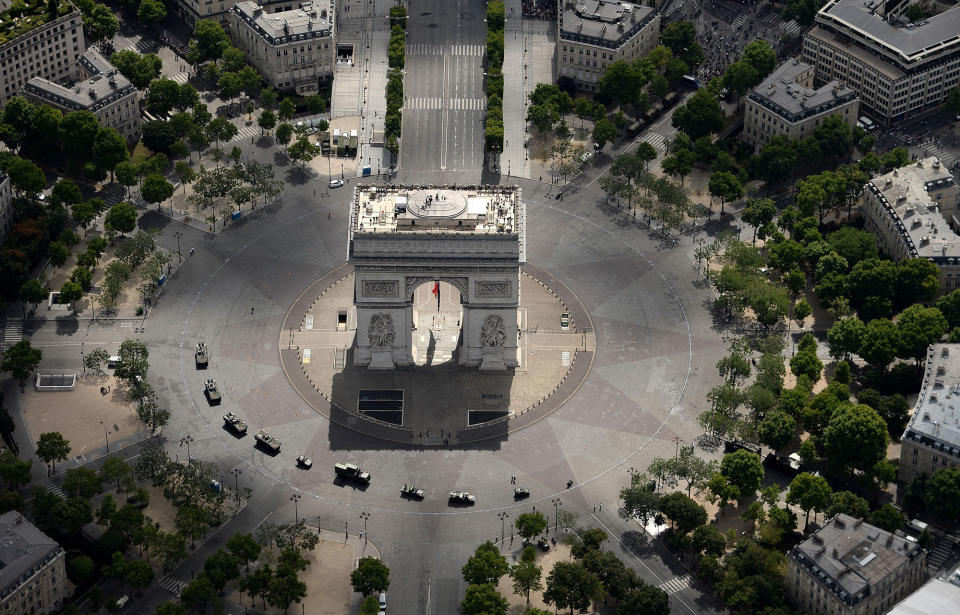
230,0 -> 337,95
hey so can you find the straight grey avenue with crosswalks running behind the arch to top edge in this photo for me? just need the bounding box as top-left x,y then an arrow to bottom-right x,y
399,0 -> 486,177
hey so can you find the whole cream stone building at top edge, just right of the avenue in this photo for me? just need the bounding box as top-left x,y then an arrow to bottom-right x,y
556,0 -> 660,92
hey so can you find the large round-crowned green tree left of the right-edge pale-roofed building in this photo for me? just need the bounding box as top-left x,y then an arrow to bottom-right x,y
823,403 -> 887,473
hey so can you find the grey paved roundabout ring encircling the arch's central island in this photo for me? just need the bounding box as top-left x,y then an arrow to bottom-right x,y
144,180 -> 723,613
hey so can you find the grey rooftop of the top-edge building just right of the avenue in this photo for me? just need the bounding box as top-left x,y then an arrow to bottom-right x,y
559,0 -> 657,49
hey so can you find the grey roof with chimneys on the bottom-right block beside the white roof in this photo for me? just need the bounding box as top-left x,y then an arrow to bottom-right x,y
789,514 -> 923,605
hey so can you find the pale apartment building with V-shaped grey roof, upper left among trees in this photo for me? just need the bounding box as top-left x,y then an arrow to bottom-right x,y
23,48 -> 143,140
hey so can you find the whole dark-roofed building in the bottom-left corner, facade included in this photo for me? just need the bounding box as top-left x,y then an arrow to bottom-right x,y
0,510 -> 73,615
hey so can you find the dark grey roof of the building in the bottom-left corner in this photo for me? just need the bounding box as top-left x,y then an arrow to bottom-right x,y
0,510 -> 62,600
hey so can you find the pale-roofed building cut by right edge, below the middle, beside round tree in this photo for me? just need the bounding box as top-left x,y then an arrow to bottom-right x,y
897,344 -> 960,483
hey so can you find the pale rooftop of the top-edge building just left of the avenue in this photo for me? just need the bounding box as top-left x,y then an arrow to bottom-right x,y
231,0 -> 333,45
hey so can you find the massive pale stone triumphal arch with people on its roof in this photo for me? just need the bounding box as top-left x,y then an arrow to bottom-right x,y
347,186 -> 526,372
